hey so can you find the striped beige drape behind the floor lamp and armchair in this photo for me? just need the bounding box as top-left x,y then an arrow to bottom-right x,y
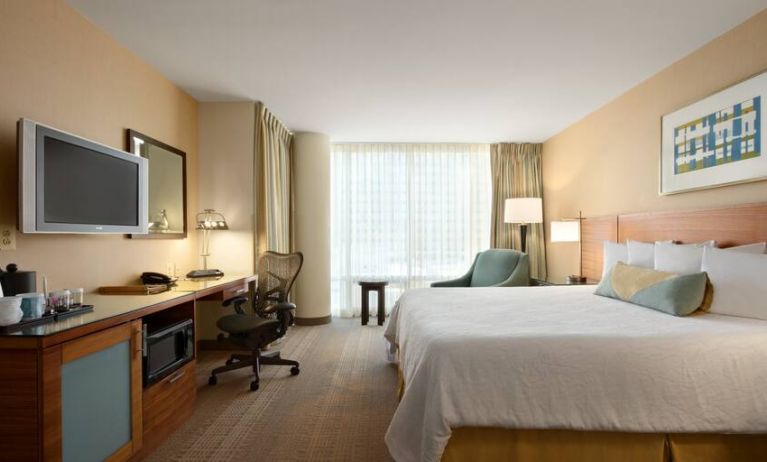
490,143 -> 546,279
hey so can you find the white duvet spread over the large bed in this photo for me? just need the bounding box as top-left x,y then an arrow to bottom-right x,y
385,286 -> 767,462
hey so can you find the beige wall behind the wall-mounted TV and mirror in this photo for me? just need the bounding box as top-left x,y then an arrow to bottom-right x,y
0,0 -> 197,289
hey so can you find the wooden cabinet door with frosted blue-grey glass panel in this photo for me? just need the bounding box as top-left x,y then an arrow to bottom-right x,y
47,320 -> 143,462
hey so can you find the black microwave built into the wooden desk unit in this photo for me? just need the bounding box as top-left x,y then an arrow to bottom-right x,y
143,319 -> 194,387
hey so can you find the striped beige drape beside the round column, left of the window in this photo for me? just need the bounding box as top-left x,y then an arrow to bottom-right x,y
254,103 -> 295,261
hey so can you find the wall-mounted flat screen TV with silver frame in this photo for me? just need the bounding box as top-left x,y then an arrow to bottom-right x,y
18,119 -> 148,234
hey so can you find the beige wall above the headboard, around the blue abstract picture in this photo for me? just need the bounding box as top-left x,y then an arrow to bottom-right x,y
543,10 -> 767,277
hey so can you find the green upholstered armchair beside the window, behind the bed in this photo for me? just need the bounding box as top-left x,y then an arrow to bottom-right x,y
431,249 -> 530,287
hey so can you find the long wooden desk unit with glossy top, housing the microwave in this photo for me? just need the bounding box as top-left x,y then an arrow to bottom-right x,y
0,275 -> 256,461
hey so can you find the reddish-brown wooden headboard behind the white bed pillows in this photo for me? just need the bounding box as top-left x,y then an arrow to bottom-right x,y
581,203 -> 767,279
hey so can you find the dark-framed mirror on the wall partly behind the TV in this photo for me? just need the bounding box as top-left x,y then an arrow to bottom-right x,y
127,129 -> 187,239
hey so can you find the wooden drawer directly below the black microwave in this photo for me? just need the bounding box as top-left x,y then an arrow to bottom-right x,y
142,361 -> 197,450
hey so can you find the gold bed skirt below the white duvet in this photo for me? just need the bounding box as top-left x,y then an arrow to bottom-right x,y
397,368 -> 767,462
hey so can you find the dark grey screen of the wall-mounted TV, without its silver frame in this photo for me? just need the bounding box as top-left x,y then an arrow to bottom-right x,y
43,136 -> 139,226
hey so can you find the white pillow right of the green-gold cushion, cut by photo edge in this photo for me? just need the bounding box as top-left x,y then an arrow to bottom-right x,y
702,247 -> 767,319
